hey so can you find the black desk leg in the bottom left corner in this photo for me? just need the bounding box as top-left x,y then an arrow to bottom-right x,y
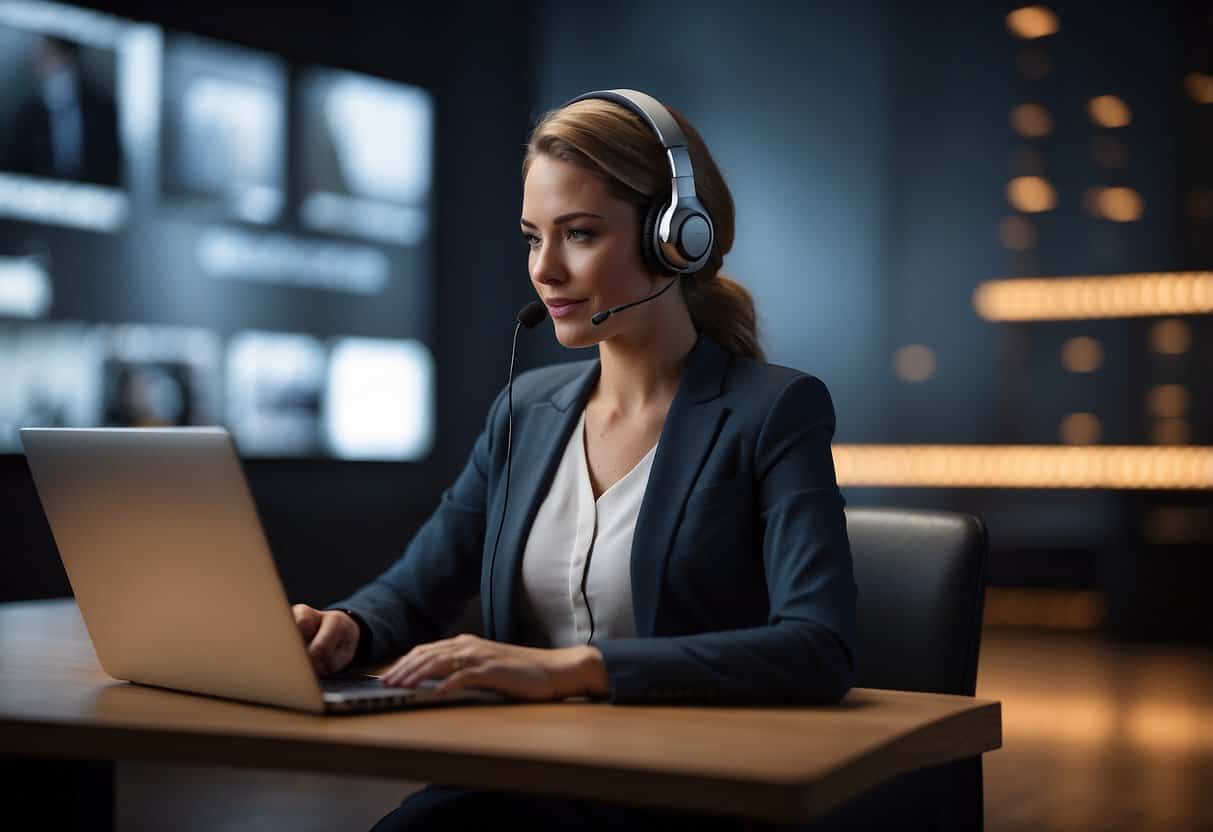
0,756 -> 115,832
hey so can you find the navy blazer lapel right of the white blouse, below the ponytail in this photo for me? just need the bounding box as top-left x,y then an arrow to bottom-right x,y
631,336 -> 729,637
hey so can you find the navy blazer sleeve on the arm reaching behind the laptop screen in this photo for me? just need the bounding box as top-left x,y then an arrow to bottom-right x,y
328,391 -> 506,662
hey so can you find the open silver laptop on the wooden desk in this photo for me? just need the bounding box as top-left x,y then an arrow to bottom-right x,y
21,428 -> 505,713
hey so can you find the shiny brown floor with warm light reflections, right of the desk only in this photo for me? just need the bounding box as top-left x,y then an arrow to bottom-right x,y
978,631 -> 1213,832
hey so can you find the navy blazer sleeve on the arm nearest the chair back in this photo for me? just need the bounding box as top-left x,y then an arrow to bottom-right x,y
594,375 -> 856,703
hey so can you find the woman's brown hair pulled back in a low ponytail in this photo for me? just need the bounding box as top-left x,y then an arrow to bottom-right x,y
523,98 -> 764,360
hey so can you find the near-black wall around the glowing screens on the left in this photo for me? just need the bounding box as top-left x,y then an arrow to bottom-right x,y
0,0 -> 530,603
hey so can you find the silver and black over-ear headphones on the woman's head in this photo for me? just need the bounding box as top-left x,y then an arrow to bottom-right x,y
563,90 -> 716,277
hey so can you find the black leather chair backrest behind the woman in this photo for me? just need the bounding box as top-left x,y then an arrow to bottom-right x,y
847,508 -> 989,696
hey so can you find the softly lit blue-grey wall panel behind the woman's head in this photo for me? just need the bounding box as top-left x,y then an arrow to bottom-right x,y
534,0 -> 892,441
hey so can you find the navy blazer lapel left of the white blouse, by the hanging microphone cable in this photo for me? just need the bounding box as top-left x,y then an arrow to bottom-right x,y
485,361 -> 602,642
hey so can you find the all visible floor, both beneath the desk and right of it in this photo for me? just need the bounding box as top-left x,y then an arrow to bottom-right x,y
118,629 -> 1213,832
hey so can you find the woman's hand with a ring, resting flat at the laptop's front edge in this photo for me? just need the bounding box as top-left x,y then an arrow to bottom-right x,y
381,634 -> 610,701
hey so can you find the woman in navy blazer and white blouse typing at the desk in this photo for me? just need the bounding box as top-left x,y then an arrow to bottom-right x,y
295,87 -> 855,830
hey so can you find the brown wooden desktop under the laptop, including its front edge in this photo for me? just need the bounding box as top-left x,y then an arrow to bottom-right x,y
0,600 -> 1002,820
